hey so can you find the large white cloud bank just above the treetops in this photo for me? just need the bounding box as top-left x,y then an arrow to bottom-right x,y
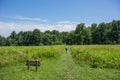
0,22 -> 76,36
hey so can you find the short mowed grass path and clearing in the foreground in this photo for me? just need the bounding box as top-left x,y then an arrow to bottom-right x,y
0,46 -> 120,80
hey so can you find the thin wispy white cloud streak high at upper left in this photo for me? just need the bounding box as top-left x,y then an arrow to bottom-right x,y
1,16 -> 47,22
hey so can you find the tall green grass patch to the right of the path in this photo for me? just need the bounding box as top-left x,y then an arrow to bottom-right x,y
70,45 -> 120,69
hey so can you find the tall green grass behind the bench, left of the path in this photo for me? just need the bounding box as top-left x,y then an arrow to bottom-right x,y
0,46 -> 63,67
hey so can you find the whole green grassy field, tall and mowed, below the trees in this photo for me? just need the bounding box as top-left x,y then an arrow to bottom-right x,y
0,45 -> 120,80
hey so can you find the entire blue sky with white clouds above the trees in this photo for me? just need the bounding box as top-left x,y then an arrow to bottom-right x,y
0,0 -> 120,37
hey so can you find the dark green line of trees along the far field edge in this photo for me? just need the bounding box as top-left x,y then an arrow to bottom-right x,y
0,20 -> 120,46
